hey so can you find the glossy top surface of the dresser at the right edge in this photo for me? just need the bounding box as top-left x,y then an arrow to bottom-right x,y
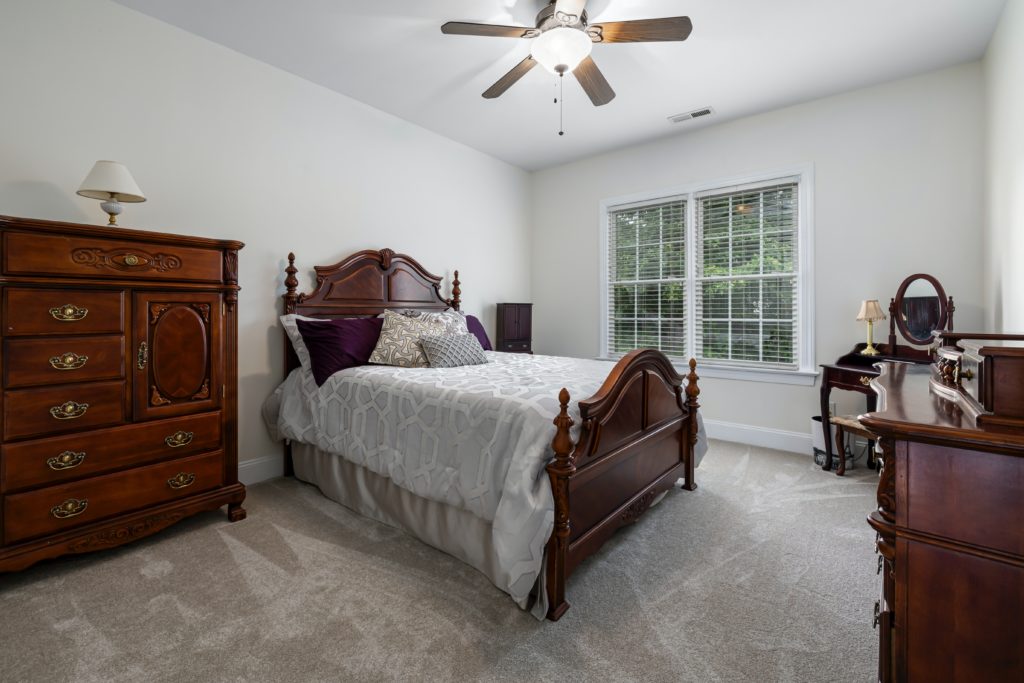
861,362 -> 1024,457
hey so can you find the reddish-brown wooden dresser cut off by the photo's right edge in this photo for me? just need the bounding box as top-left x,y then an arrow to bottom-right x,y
861,335 -> 1024,683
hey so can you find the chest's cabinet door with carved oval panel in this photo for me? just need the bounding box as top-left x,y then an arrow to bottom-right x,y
131,292 -> 223,420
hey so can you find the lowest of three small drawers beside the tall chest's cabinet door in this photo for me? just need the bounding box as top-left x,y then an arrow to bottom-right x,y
3,382 -> 125,440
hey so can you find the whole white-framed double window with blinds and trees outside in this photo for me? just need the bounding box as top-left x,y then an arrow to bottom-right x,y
602,170 -> 815,384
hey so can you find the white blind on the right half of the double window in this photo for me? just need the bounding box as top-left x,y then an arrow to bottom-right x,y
693,180 -> 800,369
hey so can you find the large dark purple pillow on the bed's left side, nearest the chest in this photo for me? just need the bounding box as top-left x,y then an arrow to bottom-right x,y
295,317 -> 384,386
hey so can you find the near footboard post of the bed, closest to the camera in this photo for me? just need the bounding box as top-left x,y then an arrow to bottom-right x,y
547,388 -> 575,622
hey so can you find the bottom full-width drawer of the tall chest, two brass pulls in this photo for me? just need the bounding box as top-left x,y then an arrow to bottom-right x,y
3,452 -> 224,544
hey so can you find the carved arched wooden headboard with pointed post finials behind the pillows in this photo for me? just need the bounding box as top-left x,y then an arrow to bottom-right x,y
285,249 -> 462,317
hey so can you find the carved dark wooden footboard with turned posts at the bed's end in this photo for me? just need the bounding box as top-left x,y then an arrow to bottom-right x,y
546,349 -> 700,621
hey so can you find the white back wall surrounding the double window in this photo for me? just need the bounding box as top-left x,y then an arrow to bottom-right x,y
531,62 -> 984,434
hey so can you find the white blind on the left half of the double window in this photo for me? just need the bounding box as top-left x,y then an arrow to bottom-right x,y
607,200 -> 687,358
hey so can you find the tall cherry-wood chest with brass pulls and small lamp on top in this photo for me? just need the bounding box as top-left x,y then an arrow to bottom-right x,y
0,216 -> 246,571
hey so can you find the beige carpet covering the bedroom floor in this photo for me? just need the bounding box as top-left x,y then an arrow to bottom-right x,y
0,441 -> 877,683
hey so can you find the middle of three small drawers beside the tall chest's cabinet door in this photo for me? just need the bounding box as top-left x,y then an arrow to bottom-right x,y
3,335 -> 125,387
